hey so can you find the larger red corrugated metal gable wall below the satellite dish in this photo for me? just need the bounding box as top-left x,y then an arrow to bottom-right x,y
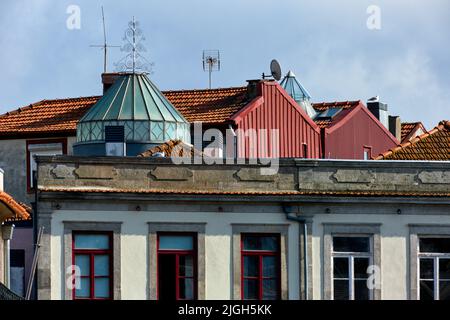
235,82 -> 320,158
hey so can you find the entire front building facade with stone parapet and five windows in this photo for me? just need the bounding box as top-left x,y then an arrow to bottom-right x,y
37,156 -> 450,300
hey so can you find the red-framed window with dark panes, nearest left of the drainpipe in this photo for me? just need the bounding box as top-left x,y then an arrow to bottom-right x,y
241,234 -> 281,300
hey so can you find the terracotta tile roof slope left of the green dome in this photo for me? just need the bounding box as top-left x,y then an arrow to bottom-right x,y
0,97 -> 99,138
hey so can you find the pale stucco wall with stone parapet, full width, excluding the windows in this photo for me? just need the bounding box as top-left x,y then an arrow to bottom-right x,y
38,157 -> 450,299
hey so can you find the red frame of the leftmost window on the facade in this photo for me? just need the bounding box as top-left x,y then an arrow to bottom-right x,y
72,231 -> 114,300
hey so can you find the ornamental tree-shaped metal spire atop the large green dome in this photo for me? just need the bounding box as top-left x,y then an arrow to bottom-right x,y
114,17 -> 154,73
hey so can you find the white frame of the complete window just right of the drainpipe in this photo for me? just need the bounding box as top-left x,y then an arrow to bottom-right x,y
331,234 -> 374,300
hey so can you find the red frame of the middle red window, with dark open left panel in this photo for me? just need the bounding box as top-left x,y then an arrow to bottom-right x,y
156,232 -> 198,300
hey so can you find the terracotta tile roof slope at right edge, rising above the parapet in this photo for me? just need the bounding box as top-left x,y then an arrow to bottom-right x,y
375,120 -> 450,161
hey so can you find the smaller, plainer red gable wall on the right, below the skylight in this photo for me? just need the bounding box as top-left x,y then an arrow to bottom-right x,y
324,106 -> 397,159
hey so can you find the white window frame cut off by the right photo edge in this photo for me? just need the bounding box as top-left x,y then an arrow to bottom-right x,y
417,236 -> 450,300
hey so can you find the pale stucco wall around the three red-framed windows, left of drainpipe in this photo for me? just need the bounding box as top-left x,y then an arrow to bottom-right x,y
47,204 -> 300,299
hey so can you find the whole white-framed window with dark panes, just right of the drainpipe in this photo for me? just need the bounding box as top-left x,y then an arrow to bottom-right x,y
332,236 -> 373,300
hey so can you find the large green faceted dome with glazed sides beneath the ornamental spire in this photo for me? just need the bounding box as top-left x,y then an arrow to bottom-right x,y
74,73 -> 190,155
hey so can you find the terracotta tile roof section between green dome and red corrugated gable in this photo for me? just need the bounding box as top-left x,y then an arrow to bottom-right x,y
163,87 -> 249,123
